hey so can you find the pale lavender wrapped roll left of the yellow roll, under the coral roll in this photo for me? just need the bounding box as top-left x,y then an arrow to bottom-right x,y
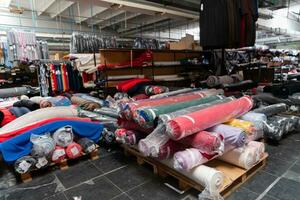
207,124 -> 247,147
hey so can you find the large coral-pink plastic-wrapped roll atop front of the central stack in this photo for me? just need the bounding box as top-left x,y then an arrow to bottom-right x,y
166,96 -> 253,140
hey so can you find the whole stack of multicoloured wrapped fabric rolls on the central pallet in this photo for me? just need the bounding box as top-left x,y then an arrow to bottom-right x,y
115,89 -> 266,196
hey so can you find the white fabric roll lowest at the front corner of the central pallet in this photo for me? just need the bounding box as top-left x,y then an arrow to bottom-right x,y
161,159 -> 224,194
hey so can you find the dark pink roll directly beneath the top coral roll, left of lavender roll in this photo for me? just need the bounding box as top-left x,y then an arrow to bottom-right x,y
178,131 -> 224,154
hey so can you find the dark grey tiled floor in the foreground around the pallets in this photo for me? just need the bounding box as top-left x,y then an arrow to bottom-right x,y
0,133 -> 300,200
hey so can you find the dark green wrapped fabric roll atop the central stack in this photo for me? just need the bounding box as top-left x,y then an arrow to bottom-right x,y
135,95 -> 225,127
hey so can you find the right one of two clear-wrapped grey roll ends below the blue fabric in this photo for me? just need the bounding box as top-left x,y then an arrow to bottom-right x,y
53,126 -> 74,147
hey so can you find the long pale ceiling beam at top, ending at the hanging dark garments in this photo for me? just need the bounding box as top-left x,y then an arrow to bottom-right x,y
98,0 -> 199,19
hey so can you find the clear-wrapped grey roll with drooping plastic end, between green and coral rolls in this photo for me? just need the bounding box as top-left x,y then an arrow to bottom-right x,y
139,97 -> 234,157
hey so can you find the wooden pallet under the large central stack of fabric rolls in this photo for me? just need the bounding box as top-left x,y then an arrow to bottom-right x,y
122,145 -> 268,198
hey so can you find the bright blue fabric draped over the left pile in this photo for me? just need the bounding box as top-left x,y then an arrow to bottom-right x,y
0,120 -> 103,164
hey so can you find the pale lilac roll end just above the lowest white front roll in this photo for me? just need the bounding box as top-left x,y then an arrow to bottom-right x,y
173,148 -> 214,171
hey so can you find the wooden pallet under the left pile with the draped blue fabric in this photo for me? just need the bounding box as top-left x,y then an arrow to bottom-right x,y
19,145 -> 99,183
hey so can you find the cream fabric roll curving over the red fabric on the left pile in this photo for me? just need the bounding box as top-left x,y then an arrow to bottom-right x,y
0,106 -> 78,135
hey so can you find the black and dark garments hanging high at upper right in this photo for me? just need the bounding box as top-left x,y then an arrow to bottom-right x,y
200,0 -> 258,49
